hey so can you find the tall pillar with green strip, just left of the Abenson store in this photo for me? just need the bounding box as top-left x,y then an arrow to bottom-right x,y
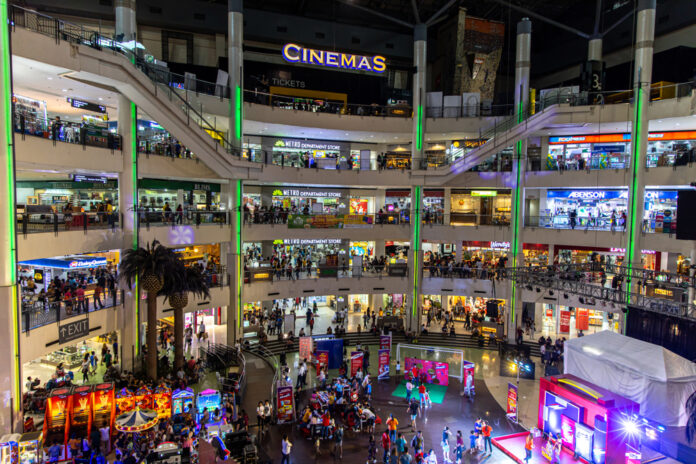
506,18 -> 532,341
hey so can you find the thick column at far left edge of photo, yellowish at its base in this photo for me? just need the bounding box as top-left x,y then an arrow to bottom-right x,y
0,0 -> 22,434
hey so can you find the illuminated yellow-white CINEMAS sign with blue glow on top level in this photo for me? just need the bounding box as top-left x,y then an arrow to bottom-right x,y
283,43 -> 387,73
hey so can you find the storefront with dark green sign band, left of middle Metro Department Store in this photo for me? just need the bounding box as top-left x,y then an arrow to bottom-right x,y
138,179 -> 225,211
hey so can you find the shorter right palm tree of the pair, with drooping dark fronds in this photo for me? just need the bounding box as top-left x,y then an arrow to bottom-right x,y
160,259 -> 210,371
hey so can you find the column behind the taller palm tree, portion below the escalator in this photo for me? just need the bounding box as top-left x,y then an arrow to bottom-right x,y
117,95 -> 142,370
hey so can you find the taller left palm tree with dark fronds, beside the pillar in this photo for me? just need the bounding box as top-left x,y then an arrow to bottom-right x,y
120,240 -> 178,380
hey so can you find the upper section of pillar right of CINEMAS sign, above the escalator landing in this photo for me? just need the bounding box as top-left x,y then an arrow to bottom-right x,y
411,24 -> 428,169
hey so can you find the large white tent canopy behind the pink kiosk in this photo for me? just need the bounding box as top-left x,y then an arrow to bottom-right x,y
564,330 -> 696,426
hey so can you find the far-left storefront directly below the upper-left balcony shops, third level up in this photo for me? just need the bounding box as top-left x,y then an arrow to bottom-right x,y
17,175 -> 118,212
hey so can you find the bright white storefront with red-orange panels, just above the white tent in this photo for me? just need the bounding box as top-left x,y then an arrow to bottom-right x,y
537,303 -> 620,338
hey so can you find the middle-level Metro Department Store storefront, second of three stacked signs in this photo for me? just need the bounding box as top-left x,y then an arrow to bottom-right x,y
271,188 -> 349,214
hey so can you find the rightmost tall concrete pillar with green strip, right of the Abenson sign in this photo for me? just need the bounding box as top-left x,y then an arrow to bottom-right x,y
624,0 -> 655,322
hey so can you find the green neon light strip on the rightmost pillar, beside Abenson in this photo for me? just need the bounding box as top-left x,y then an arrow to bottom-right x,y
624,82 -> 645,322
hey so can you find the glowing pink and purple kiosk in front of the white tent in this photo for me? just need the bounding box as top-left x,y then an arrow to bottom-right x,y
493,374 -> 640,464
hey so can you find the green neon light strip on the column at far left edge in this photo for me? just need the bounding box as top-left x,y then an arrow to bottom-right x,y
0,0 -> 22,412
